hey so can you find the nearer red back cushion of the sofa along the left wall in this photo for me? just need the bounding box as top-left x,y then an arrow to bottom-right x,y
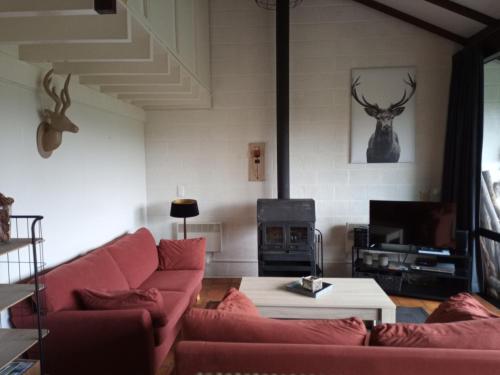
41,248 -> 129,312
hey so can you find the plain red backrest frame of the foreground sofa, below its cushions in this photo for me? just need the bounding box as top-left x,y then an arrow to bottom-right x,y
175,341 -> 500,375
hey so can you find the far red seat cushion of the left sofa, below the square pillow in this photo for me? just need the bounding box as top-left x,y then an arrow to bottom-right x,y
140,270 -> 203,294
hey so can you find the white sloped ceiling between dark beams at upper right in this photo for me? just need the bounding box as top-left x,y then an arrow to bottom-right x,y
378,0 -> 500,37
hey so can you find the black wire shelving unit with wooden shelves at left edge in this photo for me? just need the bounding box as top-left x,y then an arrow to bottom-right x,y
0,215 -> 48,374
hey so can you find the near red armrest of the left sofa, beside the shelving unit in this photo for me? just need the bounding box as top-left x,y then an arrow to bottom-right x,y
43,309 -> 154,375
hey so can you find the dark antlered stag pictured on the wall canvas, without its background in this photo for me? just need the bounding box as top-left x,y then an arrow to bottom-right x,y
351,74 -> 417,163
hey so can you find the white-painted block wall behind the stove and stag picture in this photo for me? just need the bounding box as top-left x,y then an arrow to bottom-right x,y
146,0 -> 458,276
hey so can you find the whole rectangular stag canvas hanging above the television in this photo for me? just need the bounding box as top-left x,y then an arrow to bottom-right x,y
351,67 -> 417,163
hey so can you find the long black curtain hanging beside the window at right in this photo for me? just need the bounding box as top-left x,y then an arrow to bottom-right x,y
442,47 -> 484,292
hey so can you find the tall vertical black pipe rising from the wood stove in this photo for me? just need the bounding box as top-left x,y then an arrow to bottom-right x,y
276,0 -> 290,199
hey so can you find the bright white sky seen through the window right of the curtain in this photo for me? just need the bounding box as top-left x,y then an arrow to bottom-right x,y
482,60 -> 500,181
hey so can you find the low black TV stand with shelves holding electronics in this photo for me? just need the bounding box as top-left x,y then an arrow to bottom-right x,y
352,245 -> 472,300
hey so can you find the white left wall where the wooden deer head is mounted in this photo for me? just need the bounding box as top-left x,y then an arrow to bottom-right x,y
0,49 -> 146,282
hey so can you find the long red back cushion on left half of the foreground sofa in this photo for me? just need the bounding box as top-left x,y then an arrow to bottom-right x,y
183,308 -> 366,345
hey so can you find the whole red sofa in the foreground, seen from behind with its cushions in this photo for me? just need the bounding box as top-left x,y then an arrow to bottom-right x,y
175,291 -> 500,375
